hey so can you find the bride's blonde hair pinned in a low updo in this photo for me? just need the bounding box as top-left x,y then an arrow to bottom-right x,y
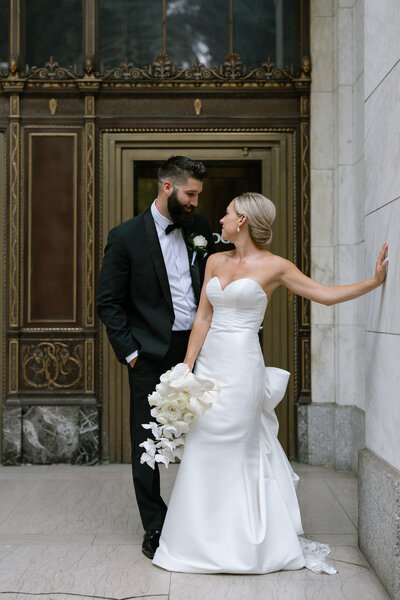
233,192 -> 276,247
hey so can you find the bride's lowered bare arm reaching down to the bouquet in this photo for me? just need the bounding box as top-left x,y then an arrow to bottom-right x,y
183,255 -> 215,370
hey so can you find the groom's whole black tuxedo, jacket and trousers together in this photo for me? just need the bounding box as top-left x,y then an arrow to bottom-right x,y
96,209 -> 215,531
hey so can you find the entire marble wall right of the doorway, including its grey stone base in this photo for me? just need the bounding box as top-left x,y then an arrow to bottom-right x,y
310,0 -> 400,600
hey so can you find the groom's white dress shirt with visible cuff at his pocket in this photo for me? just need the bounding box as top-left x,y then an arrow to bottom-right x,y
126,200 -> 197,363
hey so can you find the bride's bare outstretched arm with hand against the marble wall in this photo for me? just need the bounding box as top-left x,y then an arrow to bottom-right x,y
279,243 -> 388,306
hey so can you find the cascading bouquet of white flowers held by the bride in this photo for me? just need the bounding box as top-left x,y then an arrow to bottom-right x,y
139,363 -> 218,469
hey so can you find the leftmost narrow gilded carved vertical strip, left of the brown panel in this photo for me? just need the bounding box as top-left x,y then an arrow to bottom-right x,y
9,95 -> 20,327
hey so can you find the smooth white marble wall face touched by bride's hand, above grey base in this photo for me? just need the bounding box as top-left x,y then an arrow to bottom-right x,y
364,0 -> 400,470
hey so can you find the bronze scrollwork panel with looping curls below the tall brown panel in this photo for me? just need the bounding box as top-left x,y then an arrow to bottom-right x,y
21,341 -> 83,390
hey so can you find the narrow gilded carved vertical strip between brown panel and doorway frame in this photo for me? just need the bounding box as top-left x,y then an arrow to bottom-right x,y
84,102 -> 95,327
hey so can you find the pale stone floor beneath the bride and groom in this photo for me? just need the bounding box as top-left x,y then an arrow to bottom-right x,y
0,464 -> 388,600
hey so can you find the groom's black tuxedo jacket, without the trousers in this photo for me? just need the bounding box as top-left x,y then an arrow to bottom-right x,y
96,209 -> 215,364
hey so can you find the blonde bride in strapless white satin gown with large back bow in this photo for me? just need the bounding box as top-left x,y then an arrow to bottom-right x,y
153,193 -> 387,574
